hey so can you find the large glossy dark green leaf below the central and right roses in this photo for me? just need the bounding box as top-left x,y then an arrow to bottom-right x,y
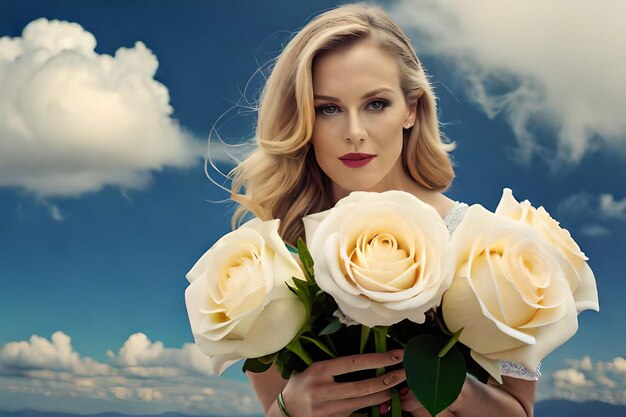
403,334 -> 466,417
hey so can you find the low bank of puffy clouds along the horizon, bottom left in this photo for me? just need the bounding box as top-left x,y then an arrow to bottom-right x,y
0,332 -> 262,415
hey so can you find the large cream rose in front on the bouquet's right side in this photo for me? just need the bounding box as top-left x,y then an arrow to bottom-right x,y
442,205 -> 596,381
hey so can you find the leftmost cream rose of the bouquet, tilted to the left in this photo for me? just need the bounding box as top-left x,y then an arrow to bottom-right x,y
185,219 -> 306,374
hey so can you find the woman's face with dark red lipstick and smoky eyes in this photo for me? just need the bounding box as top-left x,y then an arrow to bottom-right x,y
312,39 -> 415,199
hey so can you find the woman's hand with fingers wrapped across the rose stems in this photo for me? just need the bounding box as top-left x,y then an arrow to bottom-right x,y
283,350 -> 406,417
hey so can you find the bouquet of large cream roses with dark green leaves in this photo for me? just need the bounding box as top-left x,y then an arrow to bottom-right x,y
186,189 -> 598,416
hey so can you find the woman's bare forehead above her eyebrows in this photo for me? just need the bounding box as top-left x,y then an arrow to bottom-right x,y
312,39 -> 400,94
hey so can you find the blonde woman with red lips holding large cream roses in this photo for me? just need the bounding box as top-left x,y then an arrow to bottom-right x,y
232,4 -> 536,417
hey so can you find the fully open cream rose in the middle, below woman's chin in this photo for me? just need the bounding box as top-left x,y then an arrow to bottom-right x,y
303,191 -> 453,327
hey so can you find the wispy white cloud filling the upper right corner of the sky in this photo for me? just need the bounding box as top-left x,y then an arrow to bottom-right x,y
389,0 -> 626,166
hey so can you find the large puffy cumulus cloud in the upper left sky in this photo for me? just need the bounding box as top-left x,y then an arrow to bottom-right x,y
0,18 -> 204,196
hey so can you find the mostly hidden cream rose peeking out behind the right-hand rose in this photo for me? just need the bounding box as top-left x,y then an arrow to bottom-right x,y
496,188 -> 599,311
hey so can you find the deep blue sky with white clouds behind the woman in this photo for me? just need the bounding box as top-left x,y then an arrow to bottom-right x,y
0,0 -> 626,414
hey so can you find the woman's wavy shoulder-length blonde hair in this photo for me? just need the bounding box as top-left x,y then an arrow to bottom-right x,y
229,3 -> 456,244
